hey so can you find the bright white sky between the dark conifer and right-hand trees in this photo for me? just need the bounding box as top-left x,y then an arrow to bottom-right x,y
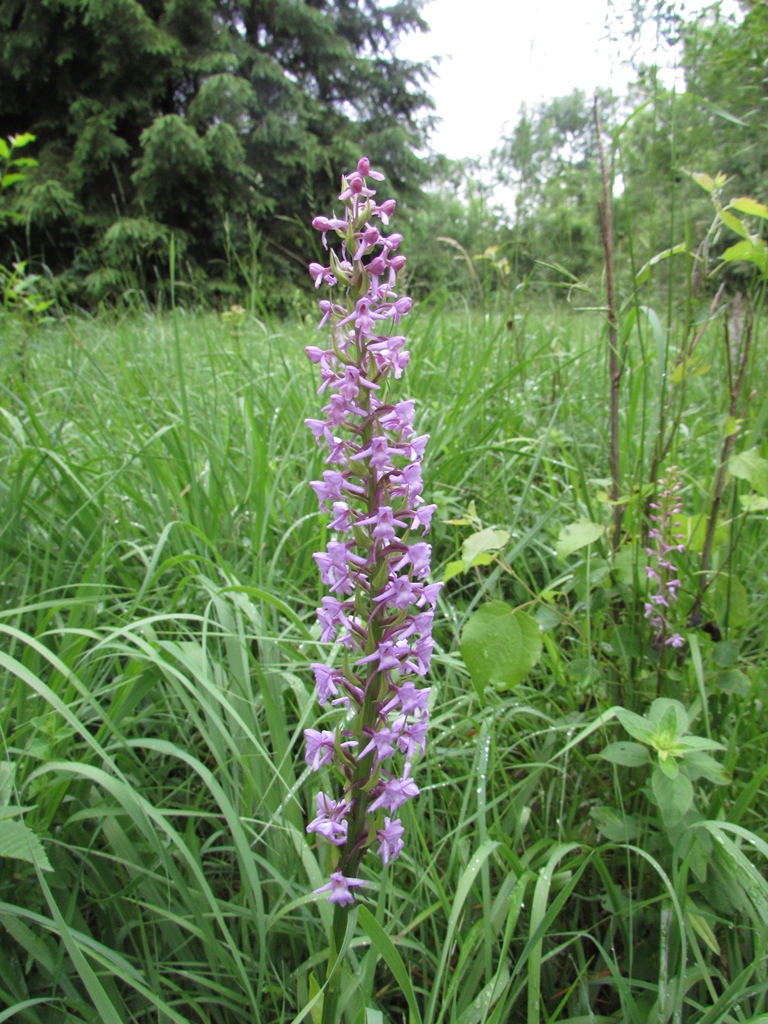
397,0 -> 741,159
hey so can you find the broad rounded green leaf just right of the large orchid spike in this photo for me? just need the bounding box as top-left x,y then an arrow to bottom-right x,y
461,601 -> 542,696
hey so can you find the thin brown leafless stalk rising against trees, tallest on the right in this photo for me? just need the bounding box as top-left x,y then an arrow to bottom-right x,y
593,96 -> 624,551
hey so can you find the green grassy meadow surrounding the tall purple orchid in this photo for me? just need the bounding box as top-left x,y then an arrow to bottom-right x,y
0,286 -> 768,1024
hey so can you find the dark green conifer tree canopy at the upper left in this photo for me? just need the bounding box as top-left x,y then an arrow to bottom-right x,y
0,0 -> 430,298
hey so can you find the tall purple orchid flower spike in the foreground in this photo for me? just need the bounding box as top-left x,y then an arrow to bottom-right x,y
305,157 -> 441,909
